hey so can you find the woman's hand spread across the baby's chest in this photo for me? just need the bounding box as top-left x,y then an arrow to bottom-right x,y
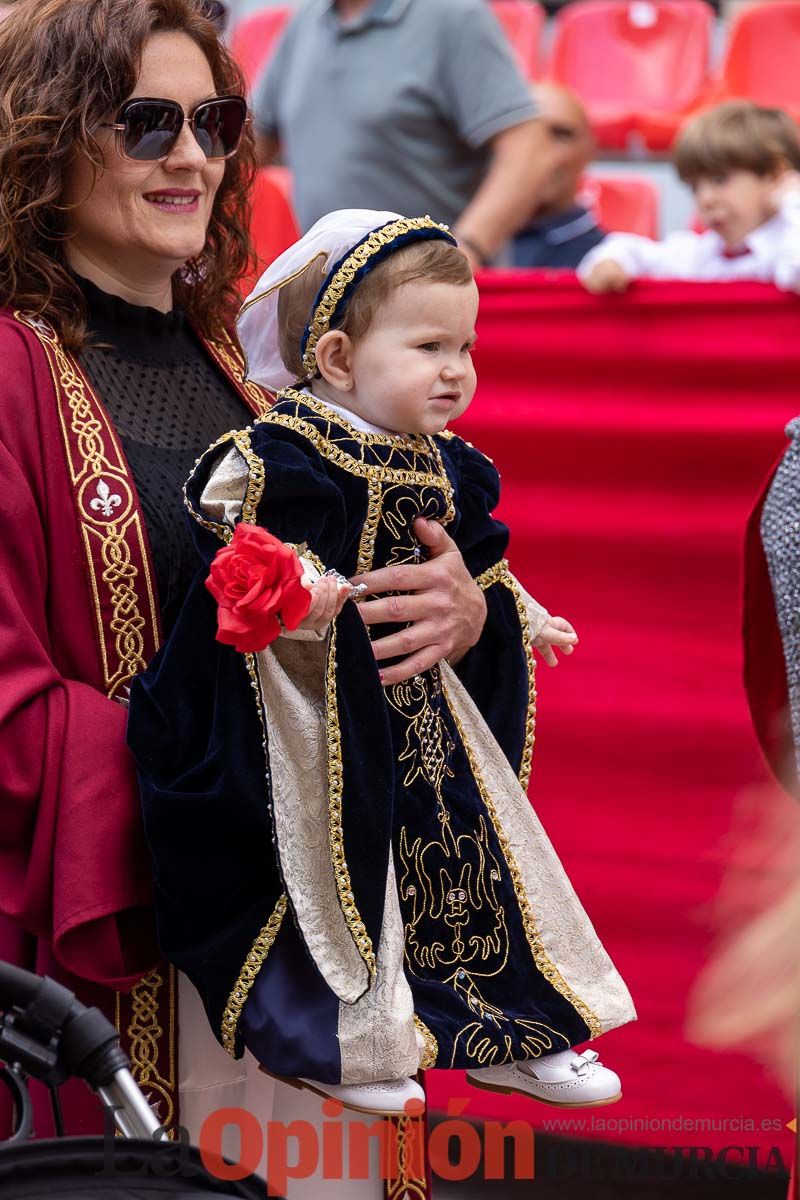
350,517 -> 486,685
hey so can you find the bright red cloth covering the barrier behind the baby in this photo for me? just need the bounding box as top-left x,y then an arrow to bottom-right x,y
429,272 -> 800,1166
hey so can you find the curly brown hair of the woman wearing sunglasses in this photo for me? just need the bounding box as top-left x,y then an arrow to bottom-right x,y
0,0 -> 255,350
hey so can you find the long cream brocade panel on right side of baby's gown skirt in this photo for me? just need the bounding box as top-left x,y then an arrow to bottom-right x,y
441,662 -> 636,1033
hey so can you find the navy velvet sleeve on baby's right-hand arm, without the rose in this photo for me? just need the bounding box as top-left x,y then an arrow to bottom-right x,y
441,437 -> 548,787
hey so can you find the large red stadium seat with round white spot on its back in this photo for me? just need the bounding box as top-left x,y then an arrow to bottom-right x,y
546,0 -> 714,149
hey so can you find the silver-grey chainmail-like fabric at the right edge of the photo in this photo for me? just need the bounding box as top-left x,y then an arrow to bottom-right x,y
762,416 -> 800,770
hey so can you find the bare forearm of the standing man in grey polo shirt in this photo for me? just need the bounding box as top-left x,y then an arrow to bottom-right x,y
453,118 -> 559,268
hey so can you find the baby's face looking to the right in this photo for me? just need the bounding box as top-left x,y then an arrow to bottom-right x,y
342,280 -> 477,433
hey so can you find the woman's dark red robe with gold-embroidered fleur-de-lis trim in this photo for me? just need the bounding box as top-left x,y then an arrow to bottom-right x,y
0,311 -> 269,1135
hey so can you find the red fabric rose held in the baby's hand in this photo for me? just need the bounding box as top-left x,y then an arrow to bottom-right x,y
205,522 -> 311,654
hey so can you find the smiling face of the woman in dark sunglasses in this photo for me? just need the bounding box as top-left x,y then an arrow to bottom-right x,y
65,32 -> 225,283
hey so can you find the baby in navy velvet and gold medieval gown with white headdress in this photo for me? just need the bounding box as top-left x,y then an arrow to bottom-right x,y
130,210 -> 636,1115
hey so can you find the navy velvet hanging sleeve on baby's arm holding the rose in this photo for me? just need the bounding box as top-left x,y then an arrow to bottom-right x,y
128,422 -> 391,1054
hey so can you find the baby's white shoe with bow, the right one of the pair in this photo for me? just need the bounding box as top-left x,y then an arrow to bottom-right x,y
467,1050 -> 622,1109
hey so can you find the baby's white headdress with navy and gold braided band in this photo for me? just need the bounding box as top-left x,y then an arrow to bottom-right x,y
236,209 -> 456,391
